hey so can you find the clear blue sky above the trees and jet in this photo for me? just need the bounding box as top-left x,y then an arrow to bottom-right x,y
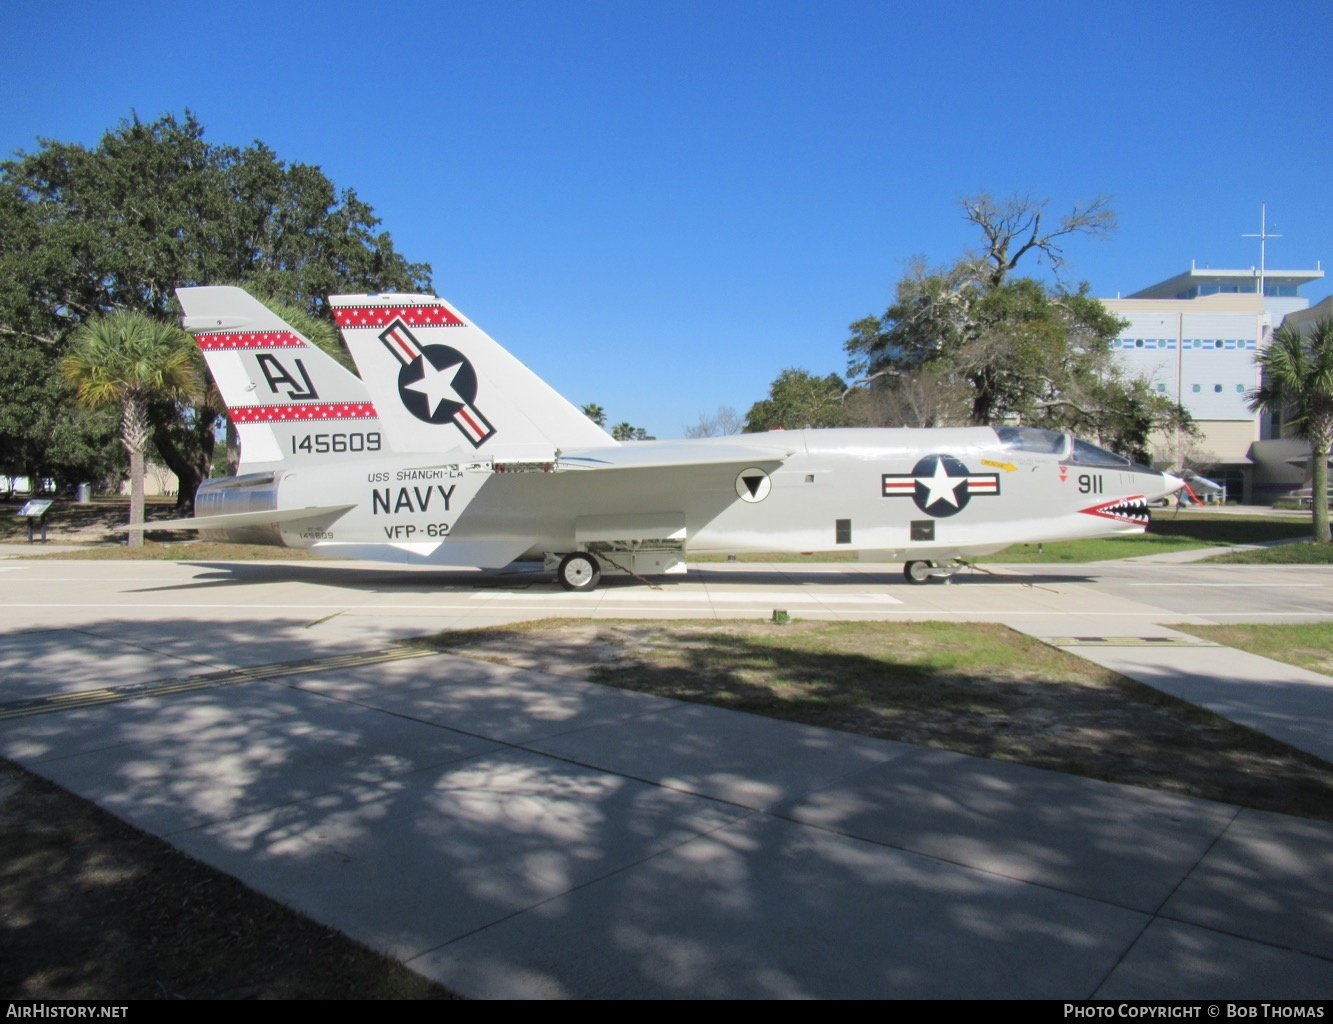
0,0 -> 1333,437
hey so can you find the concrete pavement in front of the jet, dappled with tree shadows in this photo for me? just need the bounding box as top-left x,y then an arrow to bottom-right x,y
0,561 -> 1333,999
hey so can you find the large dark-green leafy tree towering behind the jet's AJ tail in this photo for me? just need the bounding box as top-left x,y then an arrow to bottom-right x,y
0,112 -> 431,511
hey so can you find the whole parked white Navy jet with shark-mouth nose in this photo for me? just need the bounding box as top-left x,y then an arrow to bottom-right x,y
151,288 -> 1180,591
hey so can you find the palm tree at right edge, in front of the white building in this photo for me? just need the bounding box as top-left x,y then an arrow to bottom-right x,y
1248,319 -> 1333,544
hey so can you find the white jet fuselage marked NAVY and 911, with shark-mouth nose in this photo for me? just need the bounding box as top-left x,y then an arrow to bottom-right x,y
199,428 -> 1172,568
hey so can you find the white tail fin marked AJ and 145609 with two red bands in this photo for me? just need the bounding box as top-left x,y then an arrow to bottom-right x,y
176,287 -> 389,472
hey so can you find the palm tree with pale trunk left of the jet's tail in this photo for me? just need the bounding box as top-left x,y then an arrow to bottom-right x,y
60,312 -> 199,547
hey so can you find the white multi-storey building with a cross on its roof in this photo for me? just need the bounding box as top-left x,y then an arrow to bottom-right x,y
1102,267 -> 1333,504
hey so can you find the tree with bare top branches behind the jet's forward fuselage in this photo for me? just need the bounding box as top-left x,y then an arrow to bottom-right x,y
845,192 -> 1178,457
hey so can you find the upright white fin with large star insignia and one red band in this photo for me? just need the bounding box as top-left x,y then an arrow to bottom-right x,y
329,295 -> 616,460
